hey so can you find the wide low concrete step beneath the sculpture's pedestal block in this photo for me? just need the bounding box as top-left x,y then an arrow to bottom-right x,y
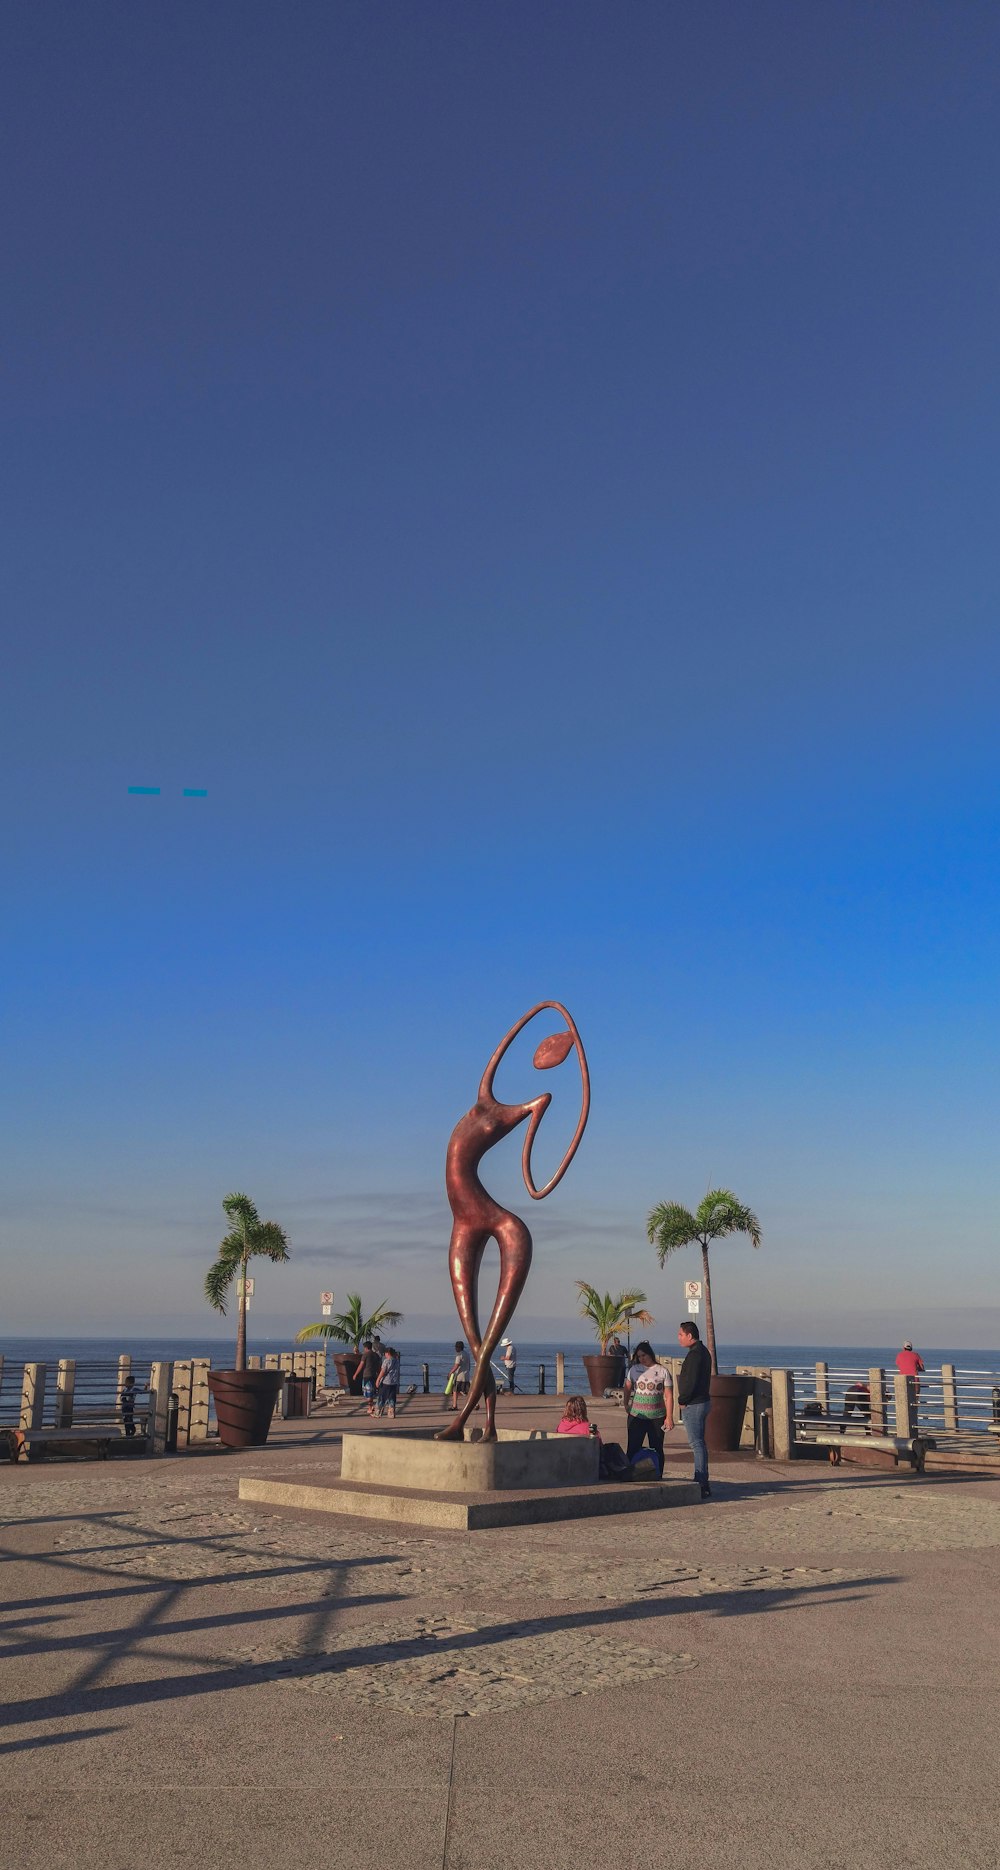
239,1473 -> 701,1532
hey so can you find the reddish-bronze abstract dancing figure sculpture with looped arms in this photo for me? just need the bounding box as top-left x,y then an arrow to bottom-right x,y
437,1000 -> 591,1442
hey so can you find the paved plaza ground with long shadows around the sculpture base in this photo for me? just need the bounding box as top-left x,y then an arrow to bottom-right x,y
0,1397 -> 1000,1870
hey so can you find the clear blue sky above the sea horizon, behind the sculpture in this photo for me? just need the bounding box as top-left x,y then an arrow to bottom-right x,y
0,0 -> 1000,1346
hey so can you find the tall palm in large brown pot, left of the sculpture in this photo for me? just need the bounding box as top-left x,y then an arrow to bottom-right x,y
206,1195 -> 288,1447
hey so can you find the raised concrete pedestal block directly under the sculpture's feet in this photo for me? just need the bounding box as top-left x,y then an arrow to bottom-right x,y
340,1431 -> 600,1494
